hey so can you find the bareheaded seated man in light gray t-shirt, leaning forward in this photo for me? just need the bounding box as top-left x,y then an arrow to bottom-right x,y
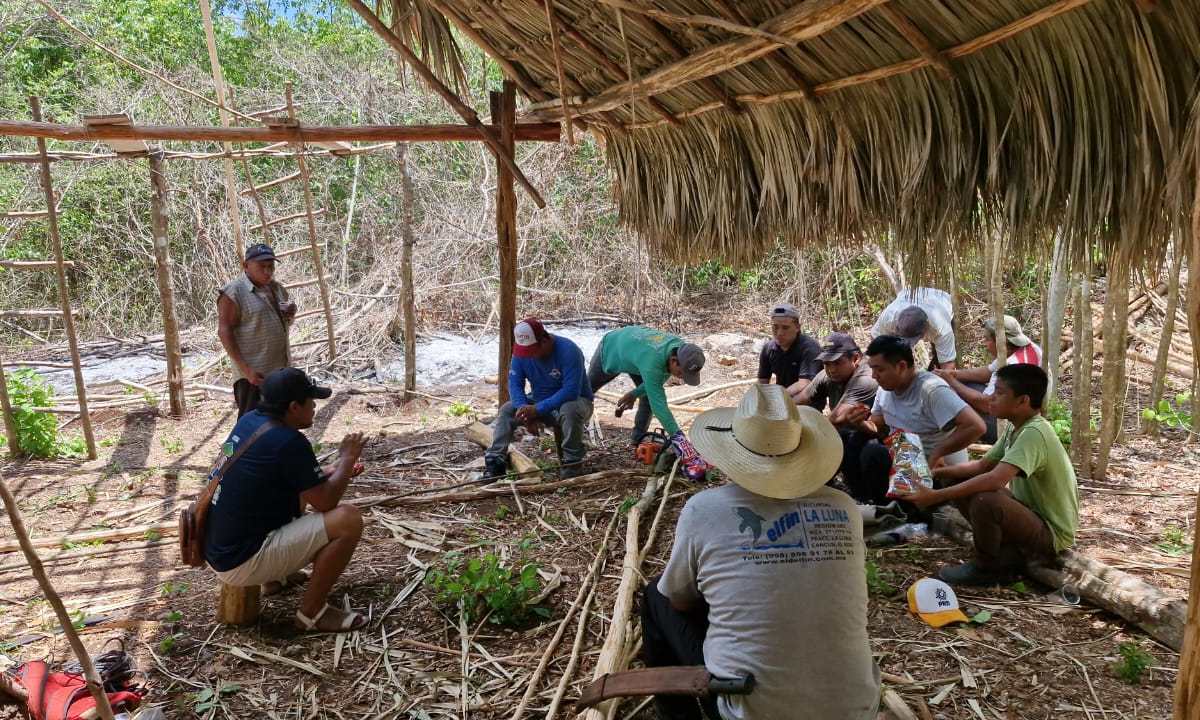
846,335 -> 984,505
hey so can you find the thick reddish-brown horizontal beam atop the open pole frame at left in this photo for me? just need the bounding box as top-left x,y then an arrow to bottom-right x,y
0,120 -> 560,144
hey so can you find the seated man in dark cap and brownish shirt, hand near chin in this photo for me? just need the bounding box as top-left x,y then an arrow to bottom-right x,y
796,332 -> 878,504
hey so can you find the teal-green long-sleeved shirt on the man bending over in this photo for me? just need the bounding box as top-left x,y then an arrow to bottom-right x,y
600,325 -> 683,434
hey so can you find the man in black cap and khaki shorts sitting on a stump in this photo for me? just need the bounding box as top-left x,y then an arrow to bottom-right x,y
204,367 -> 366,632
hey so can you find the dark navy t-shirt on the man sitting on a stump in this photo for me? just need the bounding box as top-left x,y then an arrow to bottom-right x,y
204,410 -> 325,572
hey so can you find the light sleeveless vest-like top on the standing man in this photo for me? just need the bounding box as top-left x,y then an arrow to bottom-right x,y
221,274 -> 290,382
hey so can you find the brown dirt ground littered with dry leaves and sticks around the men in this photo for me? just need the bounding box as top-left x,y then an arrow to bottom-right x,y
0,333 -> 1200,720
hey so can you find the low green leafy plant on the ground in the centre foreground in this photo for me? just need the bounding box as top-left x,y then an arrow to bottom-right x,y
425,552 -> 550,626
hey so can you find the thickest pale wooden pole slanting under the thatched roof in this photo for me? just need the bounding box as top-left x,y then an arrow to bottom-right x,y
549,0 -> 887,114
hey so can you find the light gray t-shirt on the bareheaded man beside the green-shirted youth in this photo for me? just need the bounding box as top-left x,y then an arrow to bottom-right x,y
871,370 -> 968,464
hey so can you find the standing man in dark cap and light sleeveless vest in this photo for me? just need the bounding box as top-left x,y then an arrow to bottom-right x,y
217,242 -> 296,418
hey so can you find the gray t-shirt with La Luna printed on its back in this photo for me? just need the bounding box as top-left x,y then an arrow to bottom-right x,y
659,484 -> 880,720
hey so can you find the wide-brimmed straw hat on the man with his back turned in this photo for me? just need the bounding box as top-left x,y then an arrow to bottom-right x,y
690,384 -> 841,500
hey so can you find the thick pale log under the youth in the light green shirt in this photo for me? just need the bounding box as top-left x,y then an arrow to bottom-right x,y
932,506 -> 1188,650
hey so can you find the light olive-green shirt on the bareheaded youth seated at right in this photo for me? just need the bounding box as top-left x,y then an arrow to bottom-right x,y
984,415 -> 1079,551
